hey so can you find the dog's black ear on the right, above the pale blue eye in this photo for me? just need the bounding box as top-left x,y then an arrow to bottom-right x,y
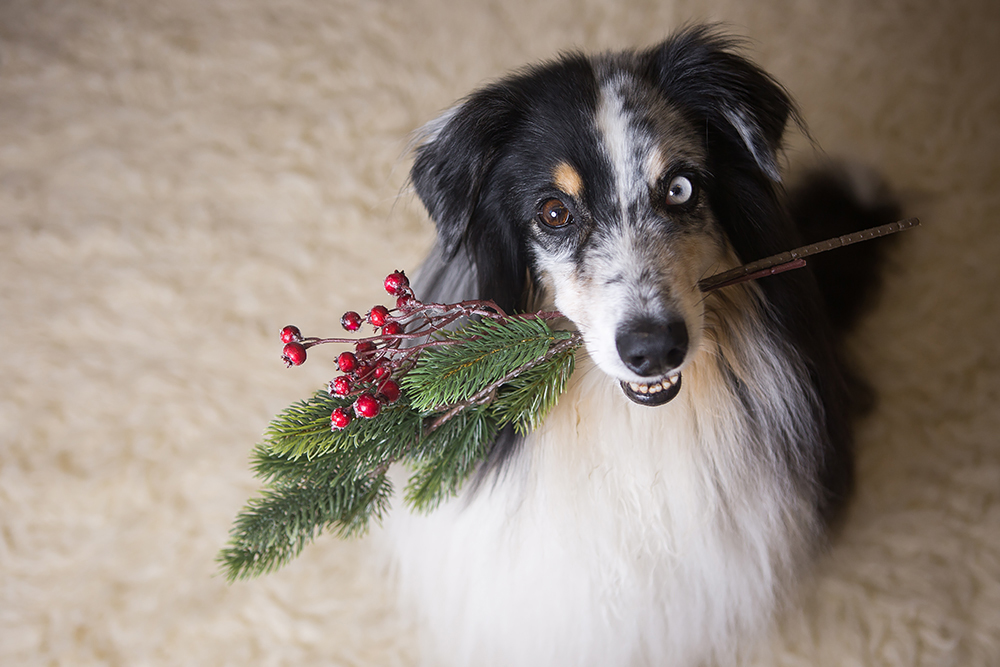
647,26 -> 797,181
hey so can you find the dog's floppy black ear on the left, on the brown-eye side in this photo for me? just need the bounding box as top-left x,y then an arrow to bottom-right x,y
410,86 -> 518,255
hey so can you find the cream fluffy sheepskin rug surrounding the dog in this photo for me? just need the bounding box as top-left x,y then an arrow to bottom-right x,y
0,0 -> 1000,666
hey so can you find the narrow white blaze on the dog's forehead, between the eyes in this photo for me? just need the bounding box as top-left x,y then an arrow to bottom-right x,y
597,77 -> 661,211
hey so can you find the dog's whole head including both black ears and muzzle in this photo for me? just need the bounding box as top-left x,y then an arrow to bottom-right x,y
412,28 -> 794,405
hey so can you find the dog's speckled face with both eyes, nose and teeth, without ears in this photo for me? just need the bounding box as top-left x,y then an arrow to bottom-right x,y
521,74 -> 725,405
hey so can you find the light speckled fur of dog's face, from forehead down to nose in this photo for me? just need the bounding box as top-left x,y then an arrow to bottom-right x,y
535,75 -> 718,383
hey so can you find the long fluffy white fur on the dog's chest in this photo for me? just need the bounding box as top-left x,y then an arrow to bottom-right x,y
385,344 -> 818,667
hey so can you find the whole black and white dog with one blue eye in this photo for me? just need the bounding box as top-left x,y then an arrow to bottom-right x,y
387,27 -> 896,667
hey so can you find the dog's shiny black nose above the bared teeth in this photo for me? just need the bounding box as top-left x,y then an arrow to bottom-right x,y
615,319 -> 688,377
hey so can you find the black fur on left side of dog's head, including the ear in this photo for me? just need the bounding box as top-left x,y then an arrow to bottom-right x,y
411,56 -> 597,312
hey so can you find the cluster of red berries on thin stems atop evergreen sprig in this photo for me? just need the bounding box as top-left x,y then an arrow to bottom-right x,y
281,271 -> 506,430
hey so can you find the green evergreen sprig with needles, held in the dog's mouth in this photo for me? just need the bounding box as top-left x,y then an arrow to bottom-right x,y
219,294 -> 581,581
